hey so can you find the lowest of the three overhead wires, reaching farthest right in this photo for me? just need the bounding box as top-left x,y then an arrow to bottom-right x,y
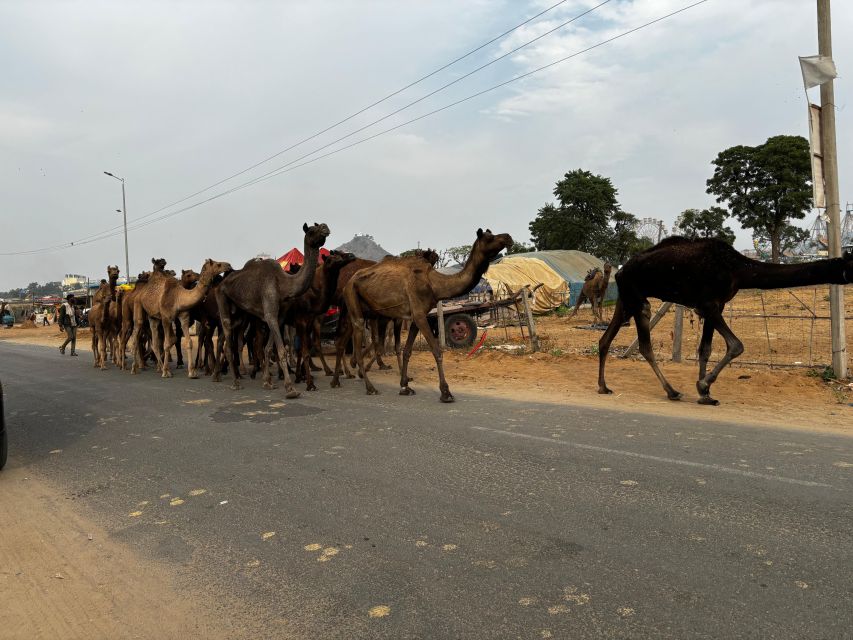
0,0 -> 708,256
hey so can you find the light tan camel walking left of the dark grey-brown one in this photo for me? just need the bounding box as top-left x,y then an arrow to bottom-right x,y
131,258 -> 231,378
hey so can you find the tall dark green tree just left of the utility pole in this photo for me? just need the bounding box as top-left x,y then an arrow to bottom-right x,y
707,136 -> 812,262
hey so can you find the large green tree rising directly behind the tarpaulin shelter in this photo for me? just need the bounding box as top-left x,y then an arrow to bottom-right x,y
530,169 -> 645,264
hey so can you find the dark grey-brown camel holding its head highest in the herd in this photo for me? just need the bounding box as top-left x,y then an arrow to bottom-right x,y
216,223 -> 329,398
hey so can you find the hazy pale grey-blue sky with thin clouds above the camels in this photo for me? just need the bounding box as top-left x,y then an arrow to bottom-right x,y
0,0 -> 853,290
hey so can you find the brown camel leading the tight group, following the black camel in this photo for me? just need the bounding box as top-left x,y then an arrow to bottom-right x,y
332,229 -> 512,402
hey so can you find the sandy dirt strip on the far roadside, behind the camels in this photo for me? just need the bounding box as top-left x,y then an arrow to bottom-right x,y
0,320 -> 853,433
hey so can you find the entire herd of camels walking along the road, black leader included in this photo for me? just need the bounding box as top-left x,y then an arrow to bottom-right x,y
83,223 -> 853,405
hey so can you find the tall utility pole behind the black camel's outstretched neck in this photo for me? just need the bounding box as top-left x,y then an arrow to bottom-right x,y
817,0 -> 847,380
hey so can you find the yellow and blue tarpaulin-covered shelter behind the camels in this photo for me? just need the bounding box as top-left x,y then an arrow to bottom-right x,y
483,250 -> 617,313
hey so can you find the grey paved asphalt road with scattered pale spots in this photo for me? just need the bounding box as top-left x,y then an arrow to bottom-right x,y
5,344 -> 853,640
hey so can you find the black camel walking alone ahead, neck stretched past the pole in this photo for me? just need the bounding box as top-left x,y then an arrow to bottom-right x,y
598,236 -> 853,405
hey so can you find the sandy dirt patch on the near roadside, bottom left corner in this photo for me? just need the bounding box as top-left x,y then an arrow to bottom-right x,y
0,467 -> 251,640
